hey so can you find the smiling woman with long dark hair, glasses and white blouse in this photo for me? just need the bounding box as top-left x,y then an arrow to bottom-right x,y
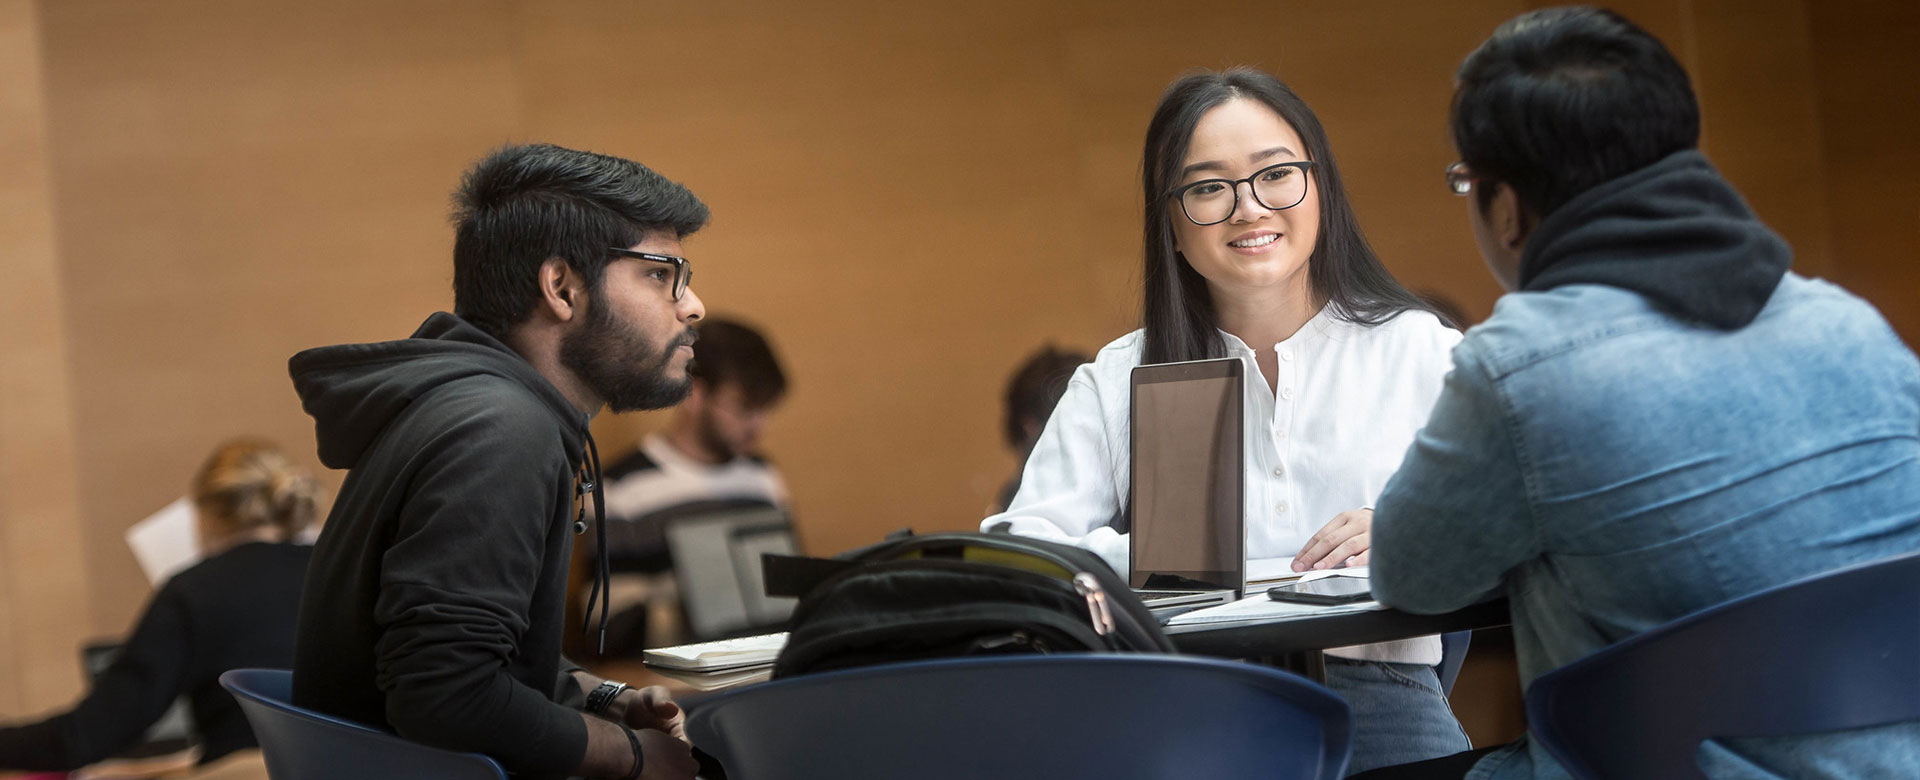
983,69 -> 1467,772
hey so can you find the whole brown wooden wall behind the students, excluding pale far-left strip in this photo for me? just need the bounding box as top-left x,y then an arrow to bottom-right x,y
6,0 -> 1920,653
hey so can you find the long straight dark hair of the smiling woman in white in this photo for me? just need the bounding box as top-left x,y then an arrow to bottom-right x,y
1140,67 -> 1427,363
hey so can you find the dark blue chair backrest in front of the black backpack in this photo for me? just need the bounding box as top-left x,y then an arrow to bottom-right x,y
687,653 -> 1352,780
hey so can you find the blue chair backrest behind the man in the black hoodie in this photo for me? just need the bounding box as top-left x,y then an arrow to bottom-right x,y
221,669 -> 507,780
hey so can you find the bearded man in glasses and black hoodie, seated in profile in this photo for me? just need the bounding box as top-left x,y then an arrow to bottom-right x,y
290,144 -> 707,778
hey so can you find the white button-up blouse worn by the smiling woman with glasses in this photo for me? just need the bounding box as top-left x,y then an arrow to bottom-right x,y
981,307 -> 1459,665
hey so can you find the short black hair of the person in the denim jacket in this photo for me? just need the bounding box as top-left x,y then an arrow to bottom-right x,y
1452,6 -> 1699,217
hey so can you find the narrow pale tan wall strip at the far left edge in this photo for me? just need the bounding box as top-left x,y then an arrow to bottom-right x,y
0,0 -> 92,713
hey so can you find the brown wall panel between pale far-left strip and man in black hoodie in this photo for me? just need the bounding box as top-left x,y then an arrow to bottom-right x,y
44,0 -> 520,634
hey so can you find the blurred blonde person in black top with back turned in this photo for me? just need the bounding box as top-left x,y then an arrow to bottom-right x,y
0,438 -> 321,772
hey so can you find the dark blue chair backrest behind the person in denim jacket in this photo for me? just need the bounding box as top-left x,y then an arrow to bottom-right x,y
1526,553 -> 1920,778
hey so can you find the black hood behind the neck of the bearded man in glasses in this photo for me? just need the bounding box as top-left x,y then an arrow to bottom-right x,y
286,311 -> 589,469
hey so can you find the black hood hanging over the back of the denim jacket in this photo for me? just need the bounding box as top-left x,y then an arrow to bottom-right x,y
1519,150 -> 1793,330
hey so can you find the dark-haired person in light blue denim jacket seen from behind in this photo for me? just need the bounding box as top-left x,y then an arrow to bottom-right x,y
1365,8 -> 1920,778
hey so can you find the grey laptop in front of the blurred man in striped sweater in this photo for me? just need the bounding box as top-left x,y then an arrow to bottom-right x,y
666,505 -> 799,640
